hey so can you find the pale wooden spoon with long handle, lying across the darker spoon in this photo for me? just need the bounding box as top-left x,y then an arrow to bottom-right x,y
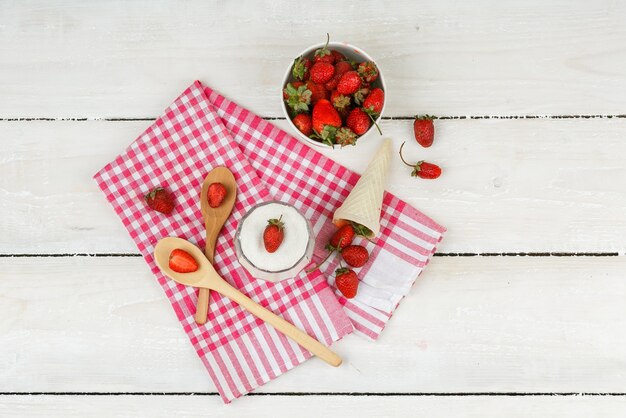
154,237 -> 341,367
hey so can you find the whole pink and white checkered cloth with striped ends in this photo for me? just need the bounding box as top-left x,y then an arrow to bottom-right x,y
94,81 -> 445,402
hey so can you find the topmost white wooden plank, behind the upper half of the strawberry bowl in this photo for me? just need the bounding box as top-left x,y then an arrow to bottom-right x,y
0,0 -> 626,117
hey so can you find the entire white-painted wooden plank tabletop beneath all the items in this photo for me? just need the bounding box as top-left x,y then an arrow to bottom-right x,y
0,0 -> 626,417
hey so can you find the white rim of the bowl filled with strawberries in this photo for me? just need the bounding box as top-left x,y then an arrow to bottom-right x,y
279,42 -> 387,148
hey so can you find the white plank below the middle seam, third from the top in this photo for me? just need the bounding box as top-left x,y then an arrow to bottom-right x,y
0,257 -> 626,396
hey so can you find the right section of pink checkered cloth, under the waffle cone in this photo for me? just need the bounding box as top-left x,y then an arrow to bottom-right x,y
200,81 -> 445,340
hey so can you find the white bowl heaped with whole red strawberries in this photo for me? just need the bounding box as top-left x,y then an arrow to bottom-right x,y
282,37 -> 386,147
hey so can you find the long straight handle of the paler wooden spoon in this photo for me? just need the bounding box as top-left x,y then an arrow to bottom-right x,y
211,278 -> 342,367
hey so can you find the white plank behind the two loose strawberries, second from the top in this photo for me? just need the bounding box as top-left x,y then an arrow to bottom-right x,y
0,119 -> 626,253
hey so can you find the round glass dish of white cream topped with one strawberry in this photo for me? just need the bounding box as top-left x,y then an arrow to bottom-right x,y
235,201 -> 315,282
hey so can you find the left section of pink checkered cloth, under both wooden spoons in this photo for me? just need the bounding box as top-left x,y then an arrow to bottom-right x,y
94,82 -> 353,403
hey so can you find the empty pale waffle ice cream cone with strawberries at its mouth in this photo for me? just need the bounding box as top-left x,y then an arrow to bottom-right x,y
333,139 -> 391,237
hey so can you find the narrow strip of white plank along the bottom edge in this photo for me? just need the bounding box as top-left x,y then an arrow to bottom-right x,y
0,396 -> 626,418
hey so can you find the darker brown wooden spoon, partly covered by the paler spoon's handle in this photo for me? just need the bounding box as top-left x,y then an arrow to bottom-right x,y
196,167 -> 237,325
